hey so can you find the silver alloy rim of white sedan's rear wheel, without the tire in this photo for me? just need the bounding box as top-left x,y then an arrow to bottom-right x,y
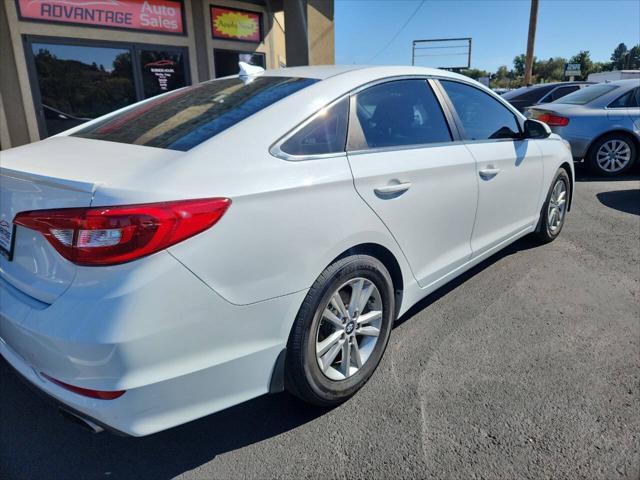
316,277 -> 383,381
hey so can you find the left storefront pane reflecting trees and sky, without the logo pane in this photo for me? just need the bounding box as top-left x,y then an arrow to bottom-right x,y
31,43 -> 136,136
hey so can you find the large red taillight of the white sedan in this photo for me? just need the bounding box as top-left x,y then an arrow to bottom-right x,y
13,198 -> 231,266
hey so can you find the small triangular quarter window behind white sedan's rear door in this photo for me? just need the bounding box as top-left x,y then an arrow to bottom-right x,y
280,98 -> 349,155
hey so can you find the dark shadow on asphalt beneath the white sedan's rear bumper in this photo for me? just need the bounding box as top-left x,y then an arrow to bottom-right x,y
0,358 -> 327,479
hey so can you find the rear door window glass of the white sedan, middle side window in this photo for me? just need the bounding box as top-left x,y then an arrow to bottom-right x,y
356,80 -> 451,148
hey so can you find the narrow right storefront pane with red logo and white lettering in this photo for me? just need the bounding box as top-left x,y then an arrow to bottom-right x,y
140,50 -> 186,98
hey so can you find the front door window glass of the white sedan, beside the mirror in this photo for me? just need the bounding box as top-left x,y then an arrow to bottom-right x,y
440,80 -> 520,140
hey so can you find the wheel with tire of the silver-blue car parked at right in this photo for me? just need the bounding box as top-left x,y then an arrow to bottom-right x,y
587,133 -> 638,177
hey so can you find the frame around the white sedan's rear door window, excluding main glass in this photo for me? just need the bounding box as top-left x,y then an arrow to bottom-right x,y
346,75 -> 462,155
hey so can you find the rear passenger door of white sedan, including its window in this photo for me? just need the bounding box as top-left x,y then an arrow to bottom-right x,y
347,79 -> 478,286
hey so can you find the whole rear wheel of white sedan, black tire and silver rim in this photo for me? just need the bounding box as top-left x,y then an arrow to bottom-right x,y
285,255 -> 395,407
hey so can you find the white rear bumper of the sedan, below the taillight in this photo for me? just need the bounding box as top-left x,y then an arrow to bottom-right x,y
0,252 -> 306,436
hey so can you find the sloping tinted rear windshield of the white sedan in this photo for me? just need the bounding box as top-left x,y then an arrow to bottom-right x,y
72,77 -> 317,151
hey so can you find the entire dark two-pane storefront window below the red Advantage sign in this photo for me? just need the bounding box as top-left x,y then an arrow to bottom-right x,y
27,37 -> 190,138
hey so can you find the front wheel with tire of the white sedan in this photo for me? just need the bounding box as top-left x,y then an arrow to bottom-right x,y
534,168 -> 571,243
